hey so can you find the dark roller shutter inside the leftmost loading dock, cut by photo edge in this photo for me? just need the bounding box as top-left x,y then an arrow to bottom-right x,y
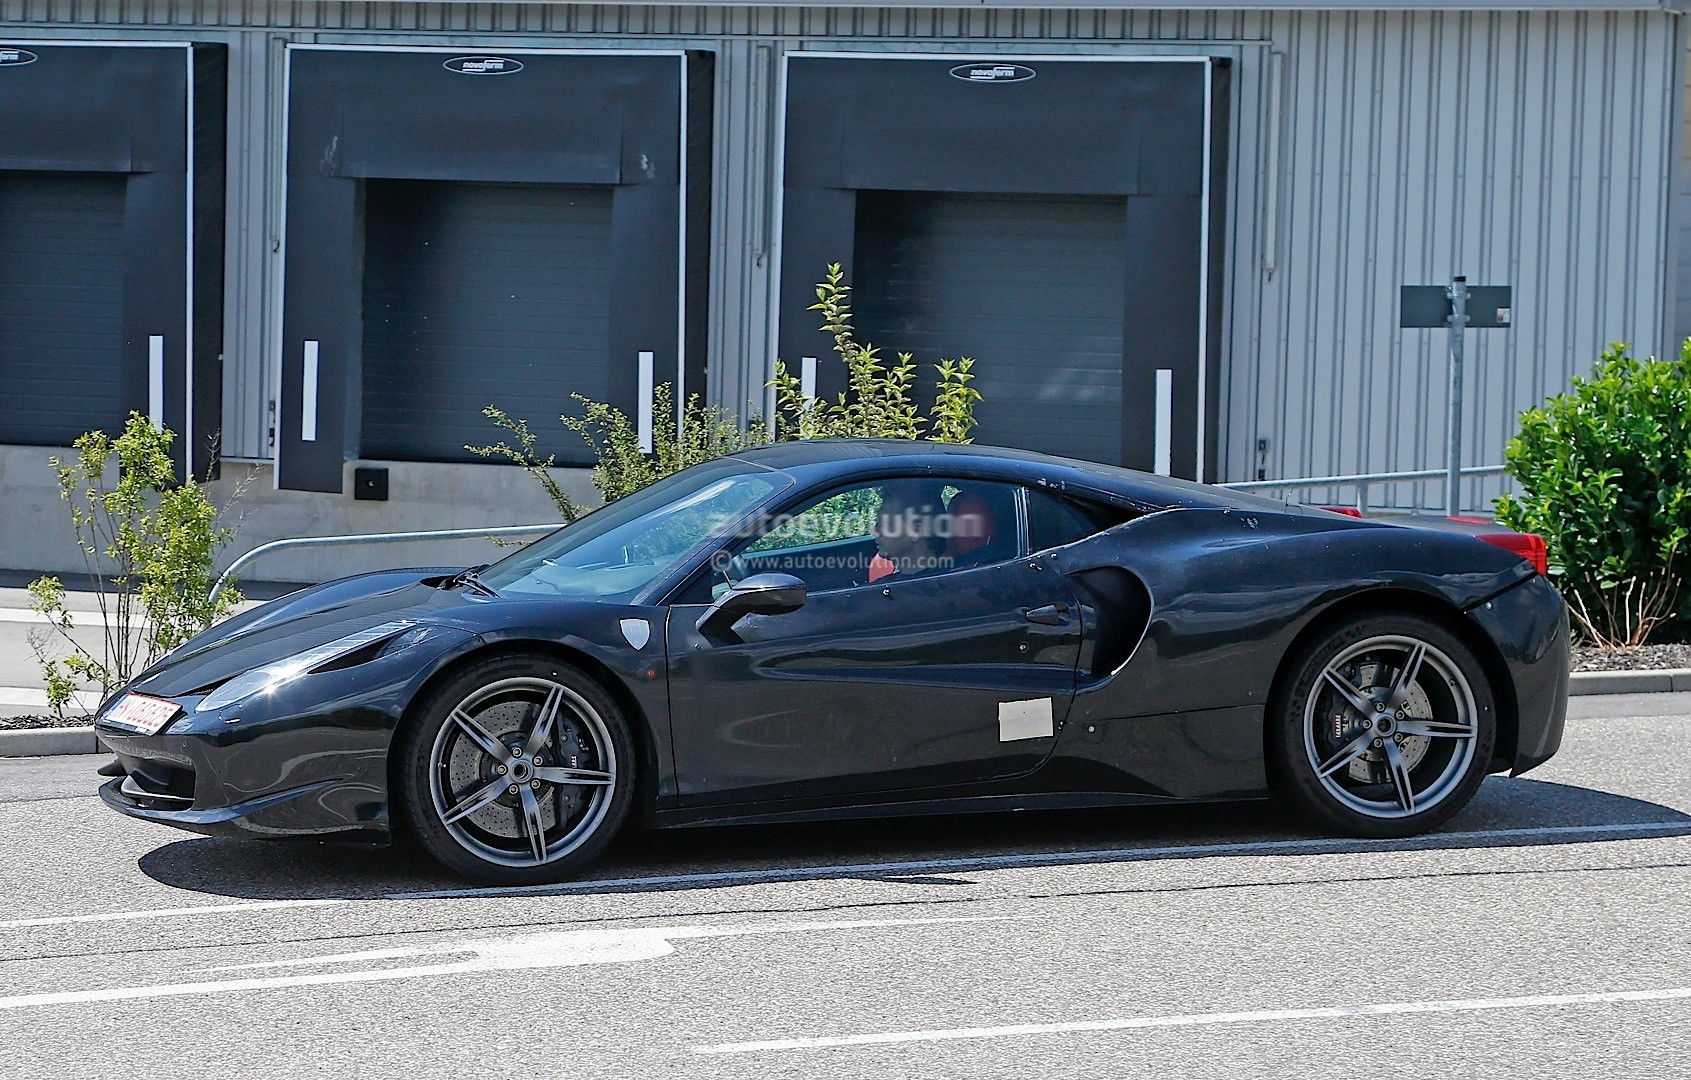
0,172 -> 125,446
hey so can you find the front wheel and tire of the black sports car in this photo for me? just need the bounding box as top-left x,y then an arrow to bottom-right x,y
394,654 -> 638,886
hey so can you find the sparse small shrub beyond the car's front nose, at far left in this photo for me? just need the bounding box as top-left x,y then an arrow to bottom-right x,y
29,412 -> 242,717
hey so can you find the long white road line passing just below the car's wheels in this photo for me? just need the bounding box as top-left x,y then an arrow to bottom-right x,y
13,821 -> 1691,930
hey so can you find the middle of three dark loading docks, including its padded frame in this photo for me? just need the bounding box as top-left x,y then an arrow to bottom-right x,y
277,46 -> 710,492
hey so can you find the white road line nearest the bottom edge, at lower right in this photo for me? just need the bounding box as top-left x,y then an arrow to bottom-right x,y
693,987 -> 1691,1055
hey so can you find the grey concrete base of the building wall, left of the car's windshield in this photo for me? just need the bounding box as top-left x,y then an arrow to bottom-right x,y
0,446 -> 599,581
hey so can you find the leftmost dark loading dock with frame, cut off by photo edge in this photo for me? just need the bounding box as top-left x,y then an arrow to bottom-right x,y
0,41 -> 227,475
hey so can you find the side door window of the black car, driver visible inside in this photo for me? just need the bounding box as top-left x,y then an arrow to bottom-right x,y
700,477 -> 1018,598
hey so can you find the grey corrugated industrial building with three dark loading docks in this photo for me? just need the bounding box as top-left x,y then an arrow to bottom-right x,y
0,0 -> 1691,573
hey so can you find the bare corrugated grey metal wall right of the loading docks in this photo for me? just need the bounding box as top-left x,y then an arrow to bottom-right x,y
1258,14 -> 1676,510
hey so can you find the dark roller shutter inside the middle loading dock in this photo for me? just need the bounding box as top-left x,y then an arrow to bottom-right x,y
360,181 -> 612,463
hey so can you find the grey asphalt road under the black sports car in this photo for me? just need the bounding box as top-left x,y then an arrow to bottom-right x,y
0,695 -> 1691,1080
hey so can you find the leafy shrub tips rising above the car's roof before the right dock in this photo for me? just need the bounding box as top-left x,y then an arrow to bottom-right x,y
769,262 -> 981,443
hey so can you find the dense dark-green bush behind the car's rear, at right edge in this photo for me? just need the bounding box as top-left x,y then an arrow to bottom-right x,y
1497,340 -> 1691,649
